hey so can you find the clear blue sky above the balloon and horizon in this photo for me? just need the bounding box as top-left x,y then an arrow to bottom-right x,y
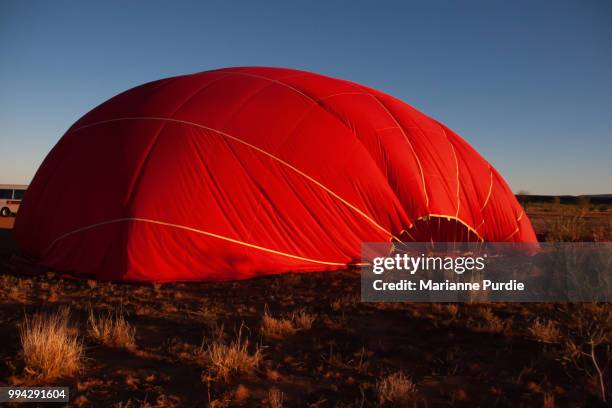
0,0 -> 612,194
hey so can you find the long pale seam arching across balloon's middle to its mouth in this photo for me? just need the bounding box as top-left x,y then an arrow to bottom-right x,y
70,116 -> 396,238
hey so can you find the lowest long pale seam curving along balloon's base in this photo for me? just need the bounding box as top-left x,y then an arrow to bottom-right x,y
45,217 -> 352,266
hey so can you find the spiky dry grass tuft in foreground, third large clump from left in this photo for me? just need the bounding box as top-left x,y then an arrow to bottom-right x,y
203,327 -> 263,381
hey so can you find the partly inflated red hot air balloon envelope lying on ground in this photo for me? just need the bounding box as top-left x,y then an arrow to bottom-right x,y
15,67 -> 536,281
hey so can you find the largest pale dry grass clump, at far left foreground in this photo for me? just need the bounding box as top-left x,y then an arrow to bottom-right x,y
19,308 -> 83,381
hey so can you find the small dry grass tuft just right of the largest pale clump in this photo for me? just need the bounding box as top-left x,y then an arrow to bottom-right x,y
87,310 -> 136,348
